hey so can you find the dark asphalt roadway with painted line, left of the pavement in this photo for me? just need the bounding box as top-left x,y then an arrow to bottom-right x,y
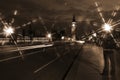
0,43 -> 81,80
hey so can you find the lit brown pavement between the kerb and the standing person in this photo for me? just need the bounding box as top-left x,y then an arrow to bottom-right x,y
65,44 -> 104,80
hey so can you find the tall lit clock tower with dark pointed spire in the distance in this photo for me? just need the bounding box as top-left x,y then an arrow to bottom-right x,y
71,15 -> 76,41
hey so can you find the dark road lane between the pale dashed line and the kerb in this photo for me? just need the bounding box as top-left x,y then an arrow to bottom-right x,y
35,46 -> 81,80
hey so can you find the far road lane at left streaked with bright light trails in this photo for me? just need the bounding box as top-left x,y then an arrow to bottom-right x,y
0,42 -> 70,59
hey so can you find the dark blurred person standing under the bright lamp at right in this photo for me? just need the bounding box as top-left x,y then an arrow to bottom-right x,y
103,34 -> 116,80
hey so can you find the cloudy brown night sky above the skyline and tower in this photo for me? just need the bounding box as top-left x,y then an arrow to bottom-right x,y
0,0 -> 120,36
